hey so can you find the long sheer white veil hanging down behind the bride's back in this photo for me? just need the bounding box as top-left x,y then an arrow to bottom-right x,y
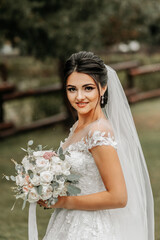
104,66 -> 154,240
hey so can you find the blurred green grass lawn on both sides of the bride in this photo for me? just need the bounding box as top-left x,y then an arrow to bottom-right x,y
0,99 -> 160,240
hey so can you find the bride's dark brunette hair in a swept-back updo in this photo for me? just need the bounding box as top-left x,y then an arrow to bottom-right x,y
64,51 -> 108,108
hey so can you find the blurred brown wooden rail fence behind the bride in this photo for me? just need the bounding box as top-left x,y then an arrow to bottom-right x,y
0,61 -> 160,139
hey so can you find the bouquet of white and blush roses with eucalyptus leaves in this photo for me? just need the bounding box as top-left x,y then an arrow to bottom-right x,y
4,140 -> 81,209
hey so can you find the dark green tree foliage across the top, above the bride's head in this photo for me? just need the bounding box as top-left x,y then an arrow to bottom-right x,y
0,0 -> 160,60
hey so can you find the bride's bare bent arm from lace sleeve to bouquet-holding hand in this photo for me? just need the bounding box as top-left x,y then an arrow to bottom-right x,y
37,146 -> 127,210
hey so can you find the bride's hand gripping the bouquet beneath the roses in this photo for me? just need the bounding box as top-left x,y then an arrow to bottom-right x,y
37,196 -> 68,209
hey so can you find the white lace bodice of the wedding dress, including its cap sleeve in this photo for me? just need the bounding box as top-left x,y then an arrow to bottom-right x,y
60,118 -> 117,195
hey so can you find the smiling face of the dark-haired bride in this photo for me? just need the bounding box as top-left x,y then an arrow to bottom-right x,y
66,72 -> 105,114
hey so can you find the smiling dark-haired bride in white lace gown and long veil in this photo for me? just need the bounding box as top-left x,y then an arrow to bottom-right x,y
38,52 -> 154,240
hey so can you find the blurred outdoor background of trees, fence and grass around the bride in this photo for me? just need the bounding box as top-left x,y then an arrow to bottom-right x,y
0,0 -> 160,240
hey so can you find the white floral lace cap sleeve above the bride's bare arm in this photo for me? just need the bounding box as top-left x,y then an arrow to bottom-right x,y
87,131 -> 117,149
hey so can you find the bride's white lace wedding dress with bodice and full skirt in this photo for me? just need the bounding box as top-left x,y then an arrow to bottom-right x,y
43,118 -> 119,240
